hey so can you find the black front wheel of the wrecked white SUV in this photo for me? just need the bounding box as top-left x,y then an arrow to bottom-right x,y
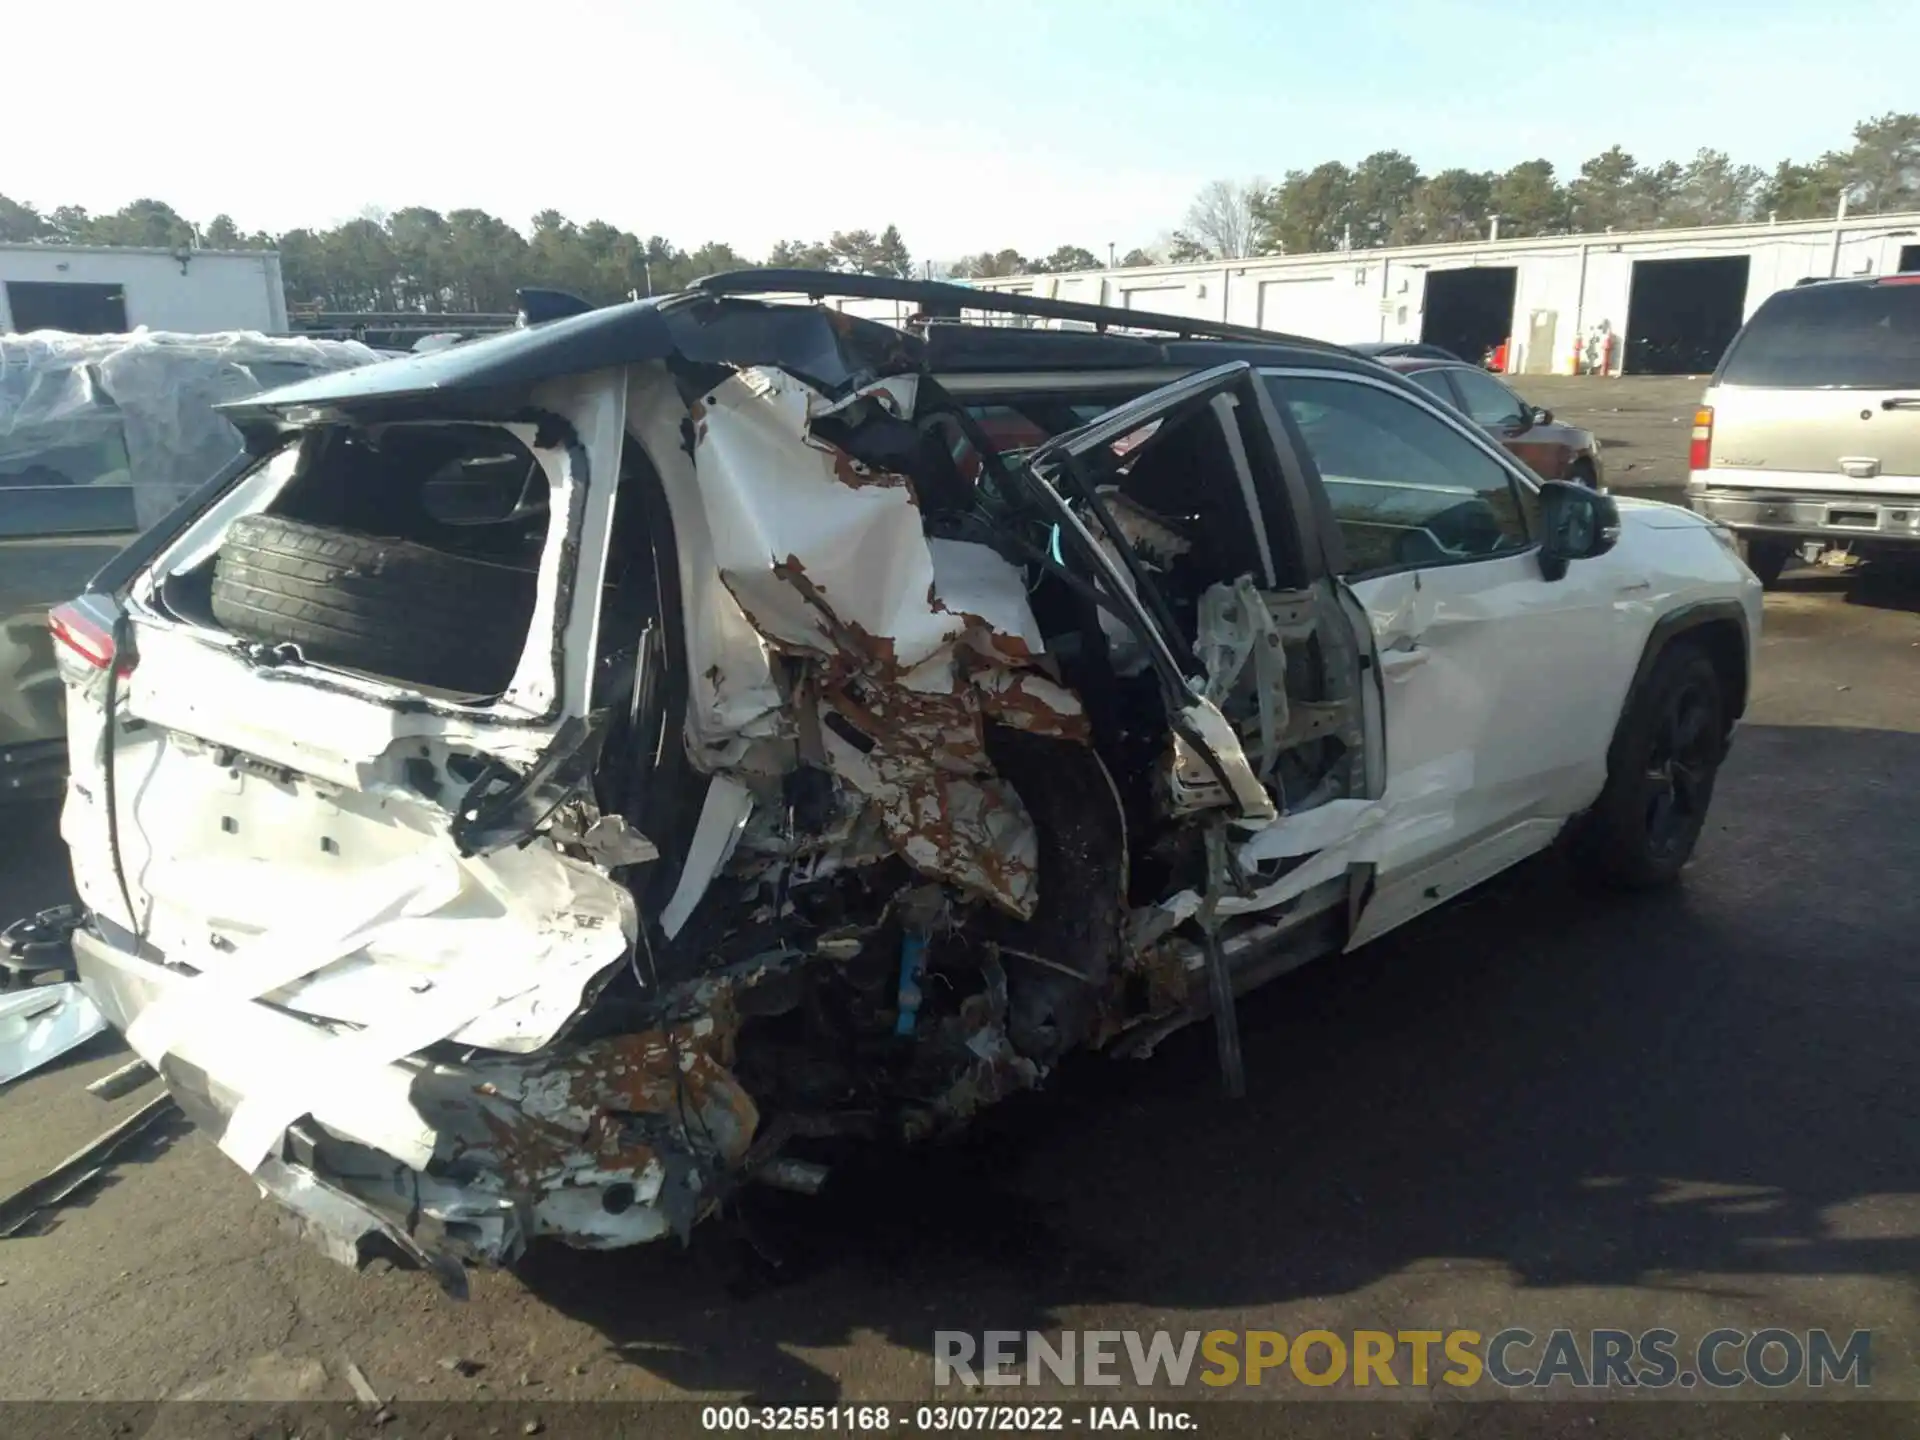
1576,639 -> 1726,889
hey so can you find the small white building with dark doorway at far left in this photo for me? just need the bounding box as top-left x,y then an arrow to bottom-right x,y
0,246 -> 286,334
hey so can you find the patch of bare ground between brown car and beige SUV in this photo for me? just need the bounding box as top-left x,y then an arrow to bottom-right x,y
1513,374 -> 1707,503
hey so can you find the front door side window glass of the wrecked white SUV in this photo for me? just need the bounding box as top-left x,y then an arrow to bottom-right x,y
1269,378 -> 1530,574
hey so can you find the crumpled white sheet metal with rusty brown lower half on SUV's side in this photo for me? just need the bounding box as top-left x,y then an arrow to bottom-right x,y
695,371 -> 1087,918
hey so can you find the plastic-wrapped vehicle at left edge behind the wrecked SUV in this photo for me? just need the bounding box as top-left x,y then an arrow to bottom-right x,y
0,330 -> 374,803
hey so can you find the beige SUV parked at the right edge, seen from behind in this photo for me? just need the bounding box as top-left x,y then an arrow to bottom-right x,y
1688,275 -> 1920,586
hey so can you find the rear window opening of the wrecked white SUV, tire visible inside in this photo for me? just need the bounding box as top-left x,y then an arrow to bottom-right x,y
161,424 -> 551,699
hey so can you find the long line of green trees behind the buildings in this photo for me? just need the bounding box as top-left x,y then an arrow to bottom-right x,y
0,113 -> 1920,313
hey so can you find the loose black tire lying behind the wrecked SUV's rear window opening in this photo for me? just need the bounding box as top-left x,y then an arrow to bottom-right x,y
213,515 -> 536,693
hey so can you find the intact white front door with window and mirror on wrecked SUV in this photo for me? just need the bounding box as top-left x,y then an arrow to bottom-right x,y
1269,371 -> 1645,945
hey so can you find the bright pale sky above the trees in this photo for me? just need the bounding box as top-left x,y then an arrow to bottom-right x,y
0,0 -> 1920,259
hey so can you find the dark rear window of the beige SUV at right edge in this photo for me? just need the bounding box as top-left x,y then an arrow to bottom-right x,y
1715,282 -> 1920,390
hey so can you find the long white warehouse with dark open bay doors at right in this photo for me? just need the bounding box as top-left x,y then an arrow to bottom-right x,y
825,213 -> 1920,374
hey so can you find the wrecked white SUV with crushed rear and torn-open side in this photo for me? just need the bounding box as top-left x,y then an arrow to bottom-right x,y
52,273 -> 1761,1288
